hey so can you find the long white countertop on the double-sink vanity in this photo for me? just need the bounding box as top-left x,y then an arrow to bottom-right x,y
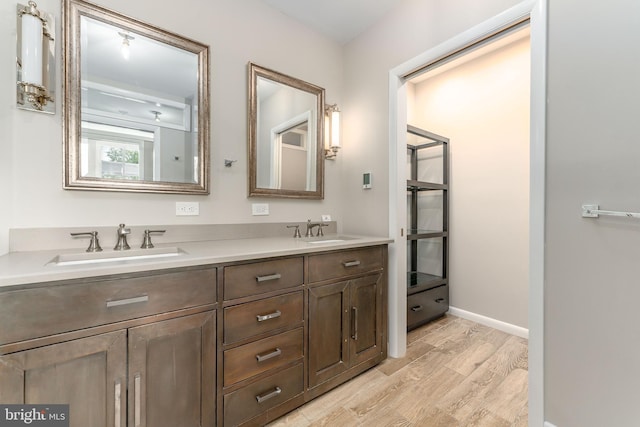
0,234 -> 392,290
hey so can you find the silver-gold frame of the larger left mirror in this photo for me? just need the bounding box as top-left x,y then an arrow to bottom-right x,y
62,0 -> 210,194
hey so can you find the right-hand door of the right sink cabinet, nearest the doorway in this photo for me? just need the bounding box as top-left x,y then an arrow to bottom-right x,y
349,274 -> 382,366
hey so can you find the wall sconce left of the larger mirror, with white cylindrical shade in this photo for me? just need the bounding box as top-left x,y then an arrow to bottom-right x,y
16,1 -> 55,113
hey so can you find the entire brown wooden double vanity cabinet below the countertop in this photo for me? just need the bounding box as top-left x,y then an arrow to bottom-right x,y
0,245 -> 387,427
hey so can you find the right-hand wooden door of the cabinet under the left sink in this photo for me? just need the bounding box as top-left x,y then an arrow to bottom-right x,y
129,311 -> 216,427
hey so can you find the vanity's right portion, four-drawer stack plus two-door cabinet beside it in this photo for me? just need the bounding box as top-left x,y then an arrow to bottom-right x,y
218,245 -> 387,426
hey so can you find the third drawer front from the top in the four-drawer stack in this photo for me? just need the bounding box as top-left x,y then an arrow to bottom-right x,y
224,328 -> 303,387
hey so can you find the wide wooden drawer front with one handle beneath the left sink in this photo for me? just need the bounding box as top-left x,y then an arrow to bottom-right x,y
0,268 -> 216,344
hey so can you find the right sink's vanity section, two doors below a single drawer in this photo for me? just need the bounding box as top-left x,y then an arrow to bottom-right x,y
308,247 -> 386,395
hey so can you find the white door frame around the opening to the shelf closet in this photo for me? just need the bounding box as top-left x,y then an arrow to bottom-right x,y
389,0 -> 548,426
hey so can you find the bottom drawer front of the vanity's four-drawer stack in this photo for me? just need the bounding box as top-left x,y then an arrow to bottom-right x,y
224,363 -> 304,426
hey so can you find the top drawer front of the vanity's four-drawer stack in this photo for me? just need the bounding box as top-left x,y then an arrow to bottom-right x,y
224,257 -> 303,301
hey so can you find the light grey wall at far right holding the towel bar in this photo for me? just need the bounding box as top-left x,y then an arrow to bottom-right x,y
545,0 -> 640,427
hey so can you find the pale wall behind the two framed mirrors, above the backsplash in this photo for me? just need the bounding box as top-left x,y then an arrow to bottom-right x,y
0,0 -> 342,253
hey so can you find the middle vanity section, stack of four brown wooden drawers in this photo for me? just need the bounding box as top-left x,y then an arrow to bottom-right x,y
219,256 -> 304,426
